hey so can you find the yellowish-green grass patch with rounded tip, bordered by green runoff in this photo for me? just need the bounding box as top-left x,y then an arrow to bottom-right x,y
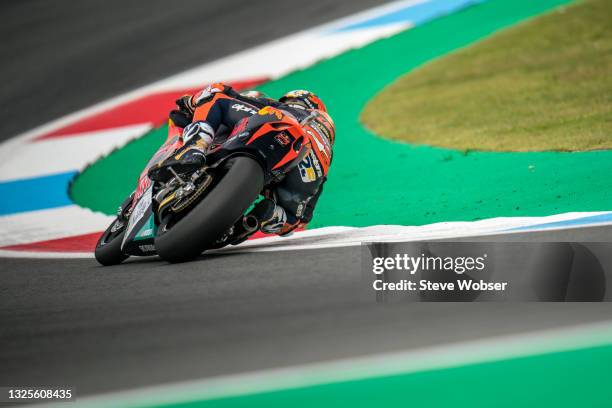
361,0 -> 612,151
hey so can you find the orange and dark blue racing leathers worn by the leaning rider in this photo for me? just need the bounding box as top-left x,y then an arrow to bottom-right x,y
170,83 -> 335,235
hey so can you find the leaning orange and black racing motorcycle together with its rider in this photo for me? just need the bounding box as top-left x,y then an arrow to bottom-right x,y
96,84 -> 335,265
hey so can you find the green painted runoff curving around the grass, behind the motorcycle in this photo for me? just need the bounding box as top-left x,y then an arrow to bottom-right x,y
71,0 -> 612,227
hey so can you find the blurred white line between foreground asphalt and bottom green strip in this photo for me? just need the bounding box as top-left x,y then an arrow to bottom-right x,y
37,321 -> 612,408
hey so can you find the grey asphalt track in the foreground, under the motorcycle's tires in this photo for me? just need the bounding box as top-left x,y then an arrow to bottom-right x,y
0,229 -> 612,395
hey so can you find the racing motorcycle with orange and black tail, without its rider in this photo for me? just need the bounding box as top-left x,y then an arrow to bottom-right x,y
95,106 -> 316,265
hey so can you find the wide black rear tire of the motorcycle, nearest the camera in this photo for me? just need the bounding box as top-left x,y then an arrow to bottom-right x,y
155,156 -> 264,262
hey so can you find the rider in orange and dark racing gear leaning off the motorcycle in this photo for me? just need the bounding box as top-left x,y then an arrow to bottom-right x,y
155,83 -> 335,235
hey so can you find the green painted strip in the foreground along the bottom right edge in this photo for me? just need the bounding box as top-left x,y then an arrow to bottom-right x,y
159,345 -> 612,408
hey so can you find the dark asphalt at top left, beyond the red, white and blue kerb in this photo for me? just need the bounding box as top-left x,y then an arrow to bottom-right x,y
0,0 -> 383,141
